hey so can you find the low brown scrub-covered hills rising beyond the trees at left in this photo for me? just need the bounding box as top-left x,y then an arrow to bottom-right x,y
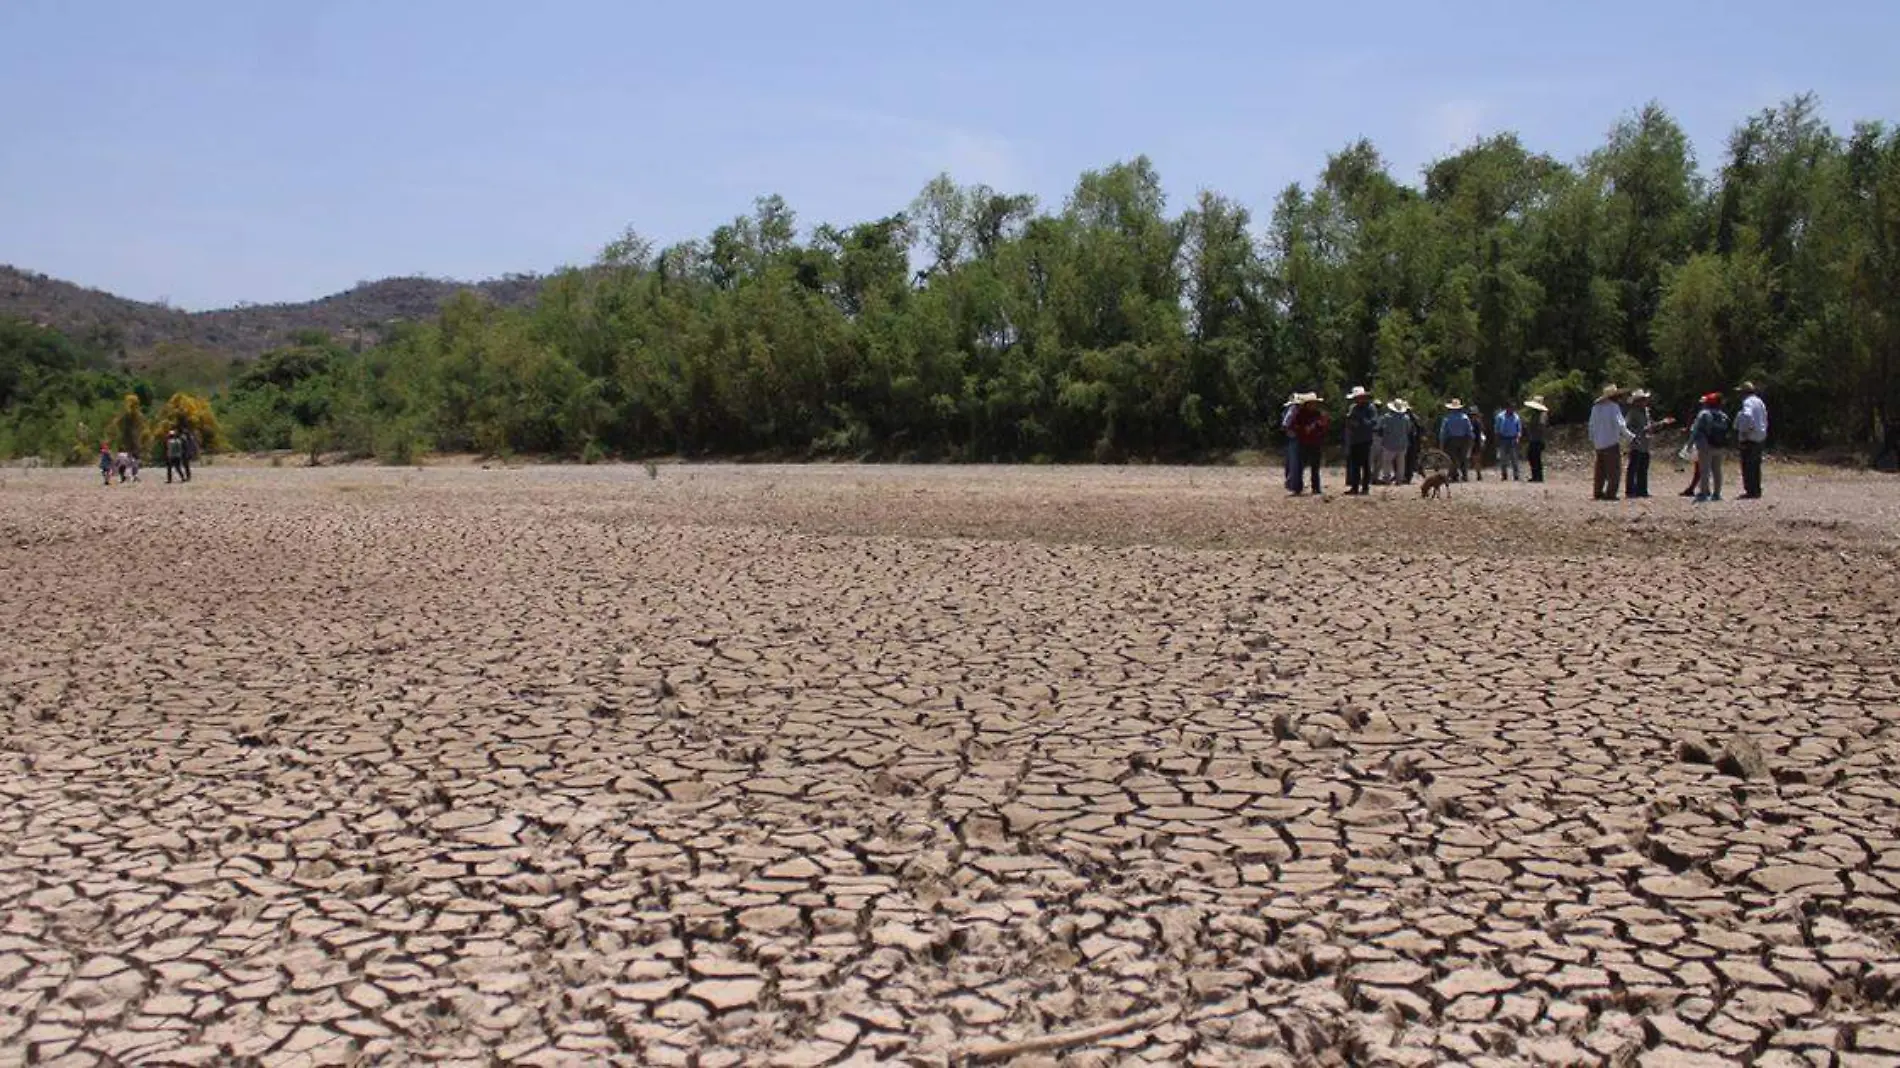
0,264 -> 543,367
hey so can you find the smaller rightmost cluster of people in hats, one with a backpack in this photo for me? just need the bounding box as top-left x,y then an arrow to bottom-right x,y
1590,382 -> 1769,504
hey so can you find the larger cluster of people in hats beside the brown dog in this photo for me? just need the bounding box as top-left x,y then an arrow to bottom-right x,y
1281,386 -> 1550,496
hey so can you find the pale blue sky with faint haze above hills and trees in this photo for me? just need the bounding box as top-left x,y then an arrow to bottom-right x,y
0,0 -> 1900,308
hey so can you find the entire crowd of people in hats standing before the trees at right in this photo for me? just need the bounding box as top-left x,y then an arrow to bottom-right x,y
1281,382 -> 1769,502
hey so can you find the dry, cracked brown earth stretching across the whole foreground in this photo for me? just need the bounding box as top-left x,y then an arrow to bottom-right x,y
0,466 -> 1900,1066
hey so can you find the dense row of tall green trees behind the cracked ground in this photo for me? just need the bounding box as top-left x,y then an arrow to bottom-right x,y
0,97 -> 1900,462
